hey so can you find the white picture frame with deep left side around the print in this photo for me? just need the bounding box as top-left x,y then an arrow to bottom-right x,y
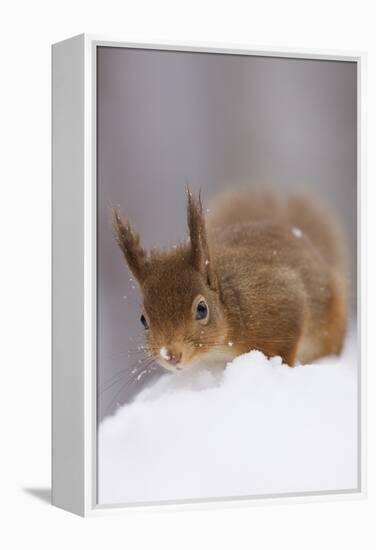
52,34 -> 366,516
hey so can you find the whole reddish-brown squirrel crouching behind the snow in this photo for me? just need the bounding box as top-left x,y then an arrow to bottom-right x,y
114,190 -> 347,369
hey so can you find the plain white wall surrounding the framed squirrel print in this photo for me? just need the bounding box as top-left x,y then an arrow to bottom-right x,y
0,0 -> 376,550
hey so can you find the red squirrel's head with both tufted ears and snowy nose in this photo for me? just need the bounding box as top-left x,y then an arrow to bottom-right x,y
114,190 -> 227,376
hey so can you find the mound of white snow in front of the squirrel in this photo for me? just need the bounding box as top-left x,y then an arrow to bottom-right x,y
98,332 -> 358,504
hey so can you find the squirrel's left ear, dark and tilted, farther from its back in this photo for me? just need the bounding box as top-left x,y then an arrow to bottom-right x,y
112,208 -> 149,283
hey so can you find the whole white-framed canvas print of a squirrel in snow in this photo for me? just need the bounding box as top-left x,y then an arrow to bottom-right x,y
52,35 -> 365,515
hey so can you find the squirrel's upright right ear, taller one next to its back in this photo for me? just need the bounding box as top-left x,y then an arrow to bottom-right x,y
187,188 -> 218,290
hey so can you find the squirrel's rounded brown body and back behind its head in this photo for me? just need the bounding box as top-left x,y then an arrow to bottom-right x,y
207,190 -> 347,364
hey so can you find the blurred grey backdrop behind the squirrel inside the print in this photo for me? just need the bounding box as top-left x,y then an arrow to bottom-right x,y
97,47 -> 357,419
